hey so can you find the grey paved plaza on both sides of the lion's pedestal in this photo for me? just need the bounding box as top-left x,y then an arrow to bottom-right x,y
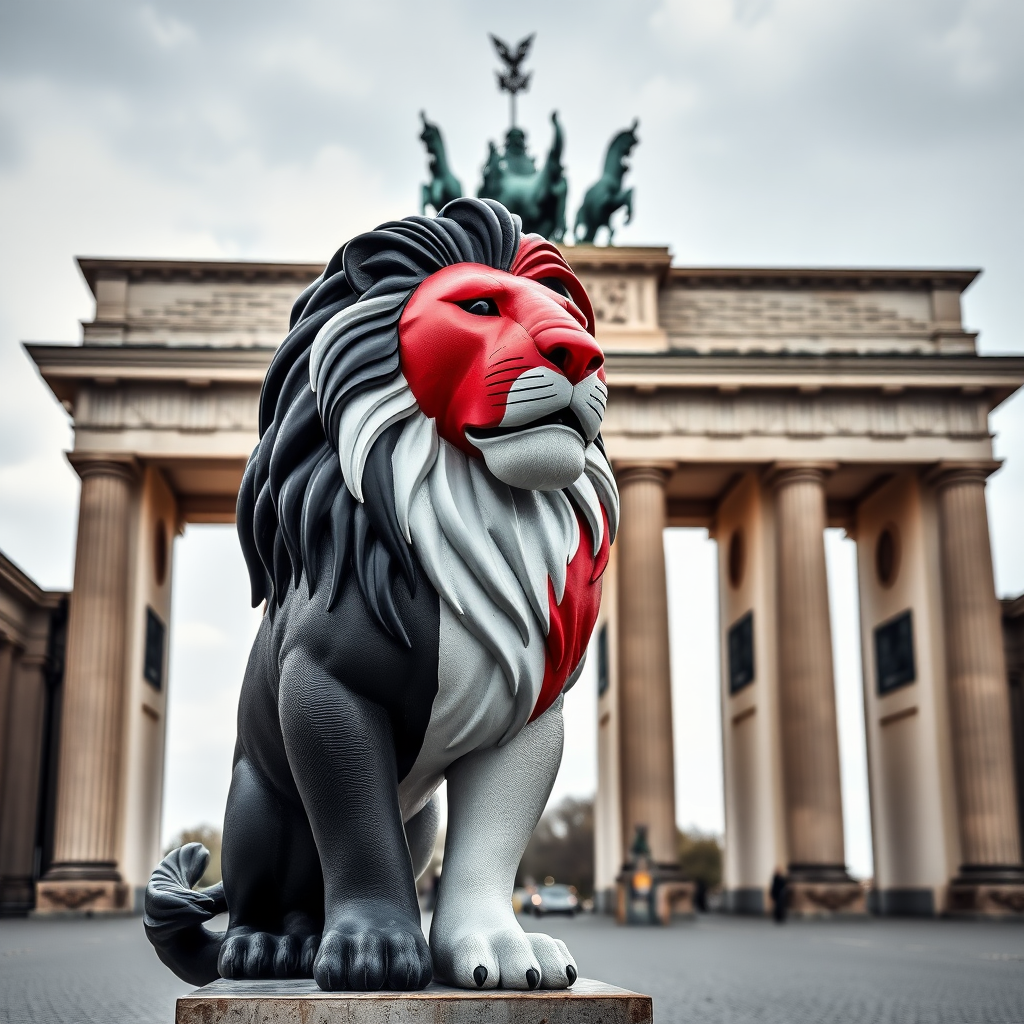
0,915 -> 1024,1024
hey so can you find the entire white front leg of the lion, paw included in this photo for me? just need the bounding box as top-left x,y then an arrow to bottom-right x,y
430,697 -> 577,988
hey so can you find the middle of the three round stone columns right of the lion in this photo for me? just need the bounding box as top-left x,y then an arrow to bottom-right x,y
766,465 -> 863,913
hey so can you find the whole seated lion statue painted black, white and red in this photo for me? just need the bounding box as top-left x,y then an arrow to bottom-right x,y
145,199 -> 618,989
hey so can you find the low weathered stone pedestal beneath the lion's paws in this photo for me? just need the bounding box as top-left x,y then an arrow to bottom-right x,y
174,978 -> 653,1024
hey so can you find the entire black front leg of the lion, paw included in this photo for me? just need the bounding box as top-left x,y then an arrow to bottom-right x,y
279,651 -> 430,989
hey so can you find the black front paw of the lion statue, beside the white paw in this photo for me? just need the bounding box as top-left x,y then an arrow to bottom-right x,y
313,920 -> 432,991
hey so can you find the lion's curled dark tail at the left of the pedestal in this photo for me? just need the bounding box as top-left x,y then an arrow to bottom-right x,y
142,843 -> 227,985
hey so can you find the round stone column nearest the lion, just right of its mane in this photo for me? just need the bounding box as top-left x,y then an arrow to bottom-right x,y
615,466 -> 678,864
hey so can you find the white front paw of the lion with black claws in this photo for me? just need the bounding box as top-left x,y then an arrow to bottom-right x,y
430,922 -> 578,989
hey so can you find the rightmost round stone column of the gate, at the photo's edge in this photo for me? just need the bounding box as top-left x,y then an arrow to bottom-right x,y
936,466 -> 1024,913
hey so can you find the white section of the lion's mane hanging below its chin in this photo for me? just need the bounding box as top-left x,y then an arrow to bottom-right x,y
339,373 -> 618,735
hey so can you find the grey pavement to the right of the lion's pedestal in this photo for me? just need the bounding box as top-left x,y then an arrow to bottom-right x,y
524,914 -> 1024,1024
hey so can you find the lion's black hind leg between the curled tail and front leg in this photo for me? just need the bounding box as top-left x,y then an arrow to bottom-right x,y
218,757 -> 322,978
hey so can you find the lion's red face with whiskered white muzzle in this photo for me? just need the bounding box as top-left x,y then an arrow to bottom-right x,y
398,247 -> 607,463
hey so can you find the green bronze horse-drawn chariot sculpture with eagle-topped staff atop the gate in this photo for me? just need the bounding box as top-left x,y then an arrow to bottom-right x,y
420,35 -> 637,244
